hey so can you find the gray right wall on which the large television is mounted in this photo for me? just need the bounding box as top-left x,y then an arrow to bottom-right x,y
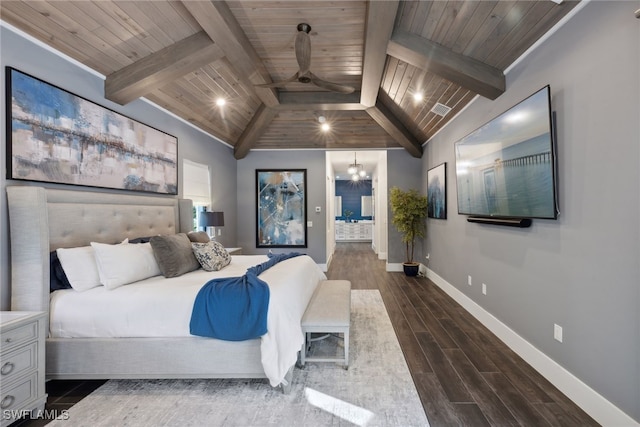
423,1 -> 640,420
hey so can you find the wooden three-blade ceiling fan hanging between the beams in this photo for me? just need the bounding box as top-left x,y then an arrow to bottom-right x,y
256,23 -> 354,93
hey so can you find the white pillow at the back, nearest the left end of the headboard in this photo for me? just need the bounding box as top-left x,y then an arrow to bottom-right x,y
56,246 -> 100,291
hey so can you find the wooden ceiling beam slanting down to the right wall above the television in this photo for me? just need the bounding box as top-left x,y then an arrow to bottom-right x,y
387,30 -> 506,99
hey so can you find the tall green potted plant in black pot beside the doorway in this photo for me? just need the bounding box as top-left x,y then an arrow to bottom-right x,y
389,187 -> 427,276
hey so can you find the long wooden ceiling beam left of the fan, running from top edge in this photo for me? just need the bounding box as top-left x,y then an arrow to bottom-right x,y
182,0 -> 279,107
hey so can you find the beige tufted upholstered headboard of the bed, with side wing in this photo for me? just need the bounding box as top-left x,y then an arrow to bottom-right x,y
7,186 -> 193,311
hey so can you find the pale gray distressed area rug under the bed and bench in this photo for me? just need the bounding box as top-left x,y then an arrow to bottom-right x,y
48,290 -> 429,427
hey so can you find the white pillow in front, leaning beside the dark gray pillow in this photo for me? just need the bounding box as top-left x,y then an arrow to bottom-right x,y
91,242 -> 160,289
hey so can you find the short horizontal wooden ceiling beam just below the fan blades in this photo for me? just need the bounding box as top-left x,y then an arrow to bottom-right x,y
276,92 -> 365,111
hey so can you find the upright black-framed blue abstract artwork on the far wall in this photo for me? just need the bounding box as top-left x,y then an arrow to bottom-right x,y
256,169 -> 307,248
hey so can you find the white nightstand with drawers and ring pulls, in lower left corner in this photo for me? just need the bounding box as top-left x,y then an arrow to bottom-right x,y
0,311 -> 47,427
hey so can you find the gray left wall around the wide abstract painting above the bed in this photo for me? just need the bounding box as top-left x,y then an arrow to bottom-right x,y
0,27 -> 237,310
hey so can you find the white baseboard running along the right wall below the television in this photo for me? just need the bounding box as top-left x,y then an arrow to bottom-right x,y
424,264 -> 640,427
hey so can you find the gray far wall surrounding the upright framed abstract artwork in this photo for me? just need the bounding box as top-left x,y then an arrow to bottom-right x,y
238,150 -> 327,264
